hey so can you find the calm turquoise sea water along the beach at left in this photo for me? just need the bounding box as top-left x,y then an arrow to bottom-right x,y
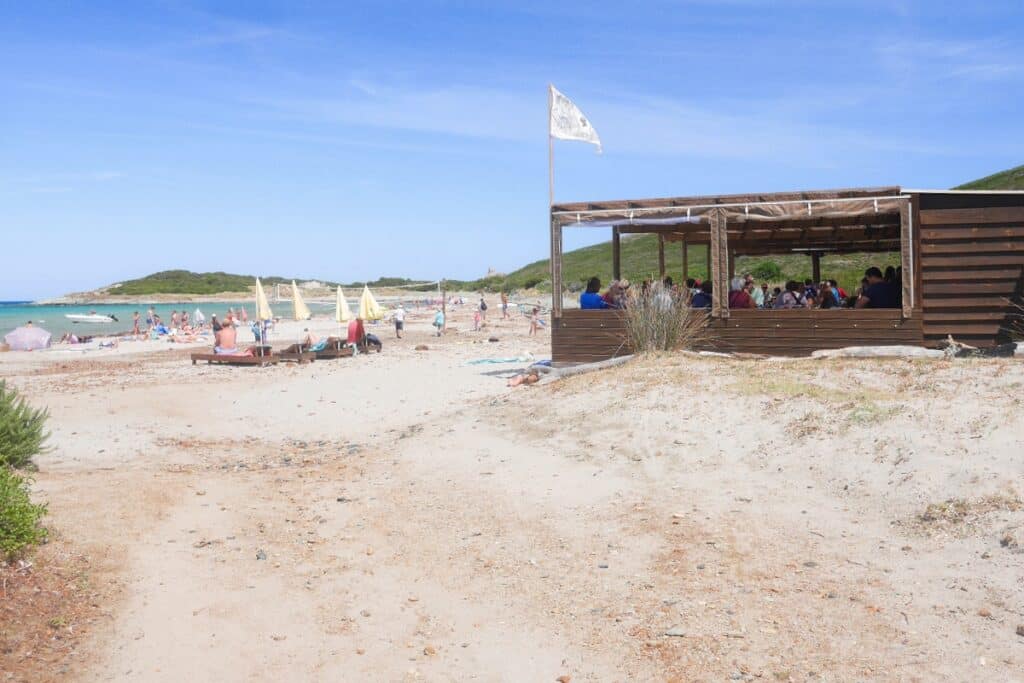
0,301 -> 334,341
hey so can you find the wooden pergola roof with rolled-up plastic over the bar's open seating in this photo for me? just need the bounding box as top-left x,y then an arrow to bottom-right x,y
551,186 -> 907,254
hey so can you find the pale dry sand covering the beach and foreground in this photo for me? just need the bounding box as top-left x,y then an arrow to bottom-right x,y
0,306 -> 1024,682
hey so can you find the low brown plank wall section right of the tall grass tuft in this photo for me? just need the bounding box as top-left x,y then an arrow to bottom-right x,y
701,308 -> 924,355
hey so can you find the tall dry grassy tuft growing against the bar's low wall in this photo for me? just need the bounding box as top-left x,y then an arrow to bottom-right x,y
623,283 -> 708,353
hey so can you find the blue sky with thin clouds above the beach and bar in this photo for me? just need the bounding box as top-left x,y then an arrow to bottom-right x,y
0,0 -> 1024,299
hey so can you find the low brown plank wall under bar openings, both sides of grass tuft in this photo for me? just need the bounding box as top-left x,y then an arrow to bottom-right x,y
551,309 -> 924,362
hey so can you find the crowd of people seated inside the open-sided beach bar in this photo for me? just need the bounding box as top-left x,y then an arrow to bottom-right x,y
580,266 -> 903,309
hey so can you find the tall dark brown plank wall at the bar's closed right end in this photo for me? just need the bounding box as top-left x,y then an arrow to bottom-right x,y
915,194 -> 1024,346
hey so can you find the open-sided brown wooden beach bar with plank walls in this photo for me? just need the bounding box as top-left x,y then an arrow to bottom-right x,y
551,187 -> 1024,362
